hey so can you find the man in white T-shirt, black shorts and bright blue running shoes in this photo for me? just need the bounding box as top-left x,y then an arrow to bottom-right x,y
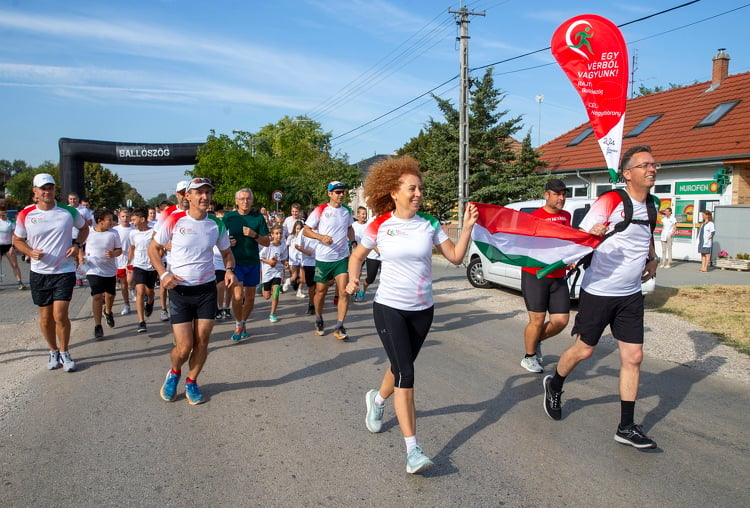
148,178 -> 236,405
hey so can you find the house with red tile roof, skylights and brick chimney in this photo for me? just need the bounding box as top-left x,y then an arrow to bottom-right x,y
538,49 -> 750,260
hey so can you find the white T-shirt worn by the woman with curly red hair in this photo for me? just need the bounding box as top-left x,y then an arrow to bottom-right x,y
362,212 -> 448,310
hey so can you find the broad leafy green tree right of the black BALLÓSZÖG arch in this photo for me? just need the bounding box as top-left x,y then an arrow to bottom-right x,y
197,116 -> 361,209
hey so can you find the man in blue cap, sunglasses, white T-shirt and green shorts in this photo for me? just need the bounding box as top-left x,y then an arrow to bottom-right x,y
302,181 -> 357,340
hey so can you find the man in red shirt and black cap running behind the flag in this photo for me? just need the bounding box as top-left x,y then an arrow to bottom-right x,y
521,179 -> 572,373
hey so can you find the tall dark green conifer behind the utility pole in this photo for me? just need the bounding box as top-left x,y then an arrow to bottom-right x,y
399,68 -> 545,220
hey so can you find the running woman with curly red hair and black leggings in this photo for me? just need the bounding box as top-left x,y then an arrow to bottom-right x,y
346,156 -> 478,473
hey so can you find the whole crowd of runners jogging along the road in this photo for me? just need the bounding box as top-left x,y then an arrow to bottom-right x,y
5,147 -> 659,473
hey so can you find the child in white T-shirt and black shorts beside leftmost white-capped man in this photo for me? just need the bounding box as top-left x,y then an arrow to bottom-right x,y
84,208 -> 122,340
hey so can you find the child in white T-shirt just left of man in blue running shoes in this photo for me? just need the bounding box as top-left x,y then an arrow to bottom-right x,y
127,207 -> 158,333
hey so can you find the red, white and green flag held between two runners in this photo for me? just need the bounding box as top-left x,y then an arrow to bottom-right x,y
471,203 -> 602,279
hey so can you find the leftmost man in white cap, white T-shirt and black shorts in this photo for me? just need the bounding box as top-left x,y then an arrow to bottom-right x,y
13,173 -> 89,372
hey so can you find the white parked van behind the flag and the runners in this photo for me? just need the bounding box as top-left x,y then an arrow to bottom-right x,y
466,198 -> 656,300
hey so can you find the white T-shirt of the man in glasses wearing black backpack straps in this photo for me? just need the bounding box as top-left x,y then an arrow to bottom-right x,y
580,192 -> 651,296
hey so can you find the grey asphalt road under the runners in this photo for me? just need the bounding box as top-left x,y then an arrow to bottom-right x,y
0,265 -> 750,507
